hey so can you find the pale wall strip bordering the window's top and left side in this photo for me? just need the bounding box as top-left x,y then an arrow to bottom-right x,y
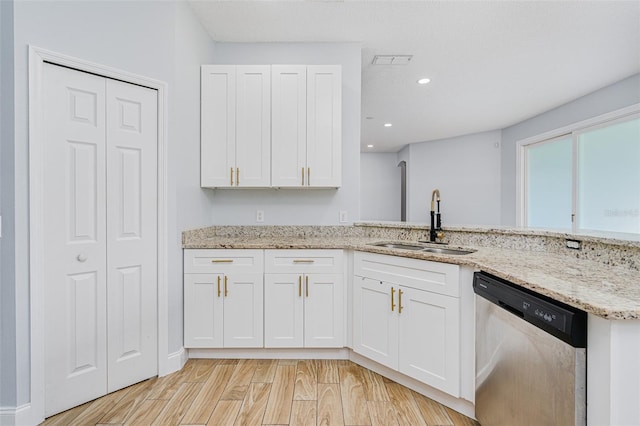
501,74 -> 640,226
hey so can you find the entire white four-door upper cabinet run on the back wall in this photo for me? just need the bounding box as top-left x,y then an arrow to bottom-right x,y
201,65 -> 342,188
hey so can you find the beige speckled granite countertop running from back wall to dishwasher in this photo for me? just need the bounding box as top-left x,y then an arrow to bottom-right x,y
183,235 -> 640,320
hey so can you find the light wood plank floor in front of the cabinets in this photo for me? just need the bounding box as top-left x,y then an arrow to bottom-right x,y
43,359 -> 478,426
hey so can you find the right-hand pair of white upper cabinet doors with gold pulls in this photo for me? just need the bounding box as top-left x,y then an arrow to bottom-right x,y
271,65 -> 342,188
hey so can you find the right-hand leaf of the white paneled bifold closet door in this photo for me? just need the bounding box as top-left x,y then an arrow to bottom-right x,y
106,80 -> 158,392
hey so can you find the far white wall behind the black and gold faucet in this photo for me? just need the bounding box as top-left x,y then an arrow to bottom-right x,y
407,130 -> 501,227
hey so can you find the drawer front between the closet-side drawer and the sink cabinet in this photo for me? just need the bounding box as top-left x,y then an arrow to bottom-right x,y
264,249 -> 344,274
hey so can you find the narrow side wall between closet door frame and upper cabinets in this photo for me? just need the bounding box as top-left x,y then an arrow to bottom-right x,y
168,2 -> 215,362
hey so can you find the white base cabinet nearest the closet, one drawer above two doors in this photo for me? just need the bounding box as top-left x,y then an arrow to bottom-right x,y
184,250 -> 264,348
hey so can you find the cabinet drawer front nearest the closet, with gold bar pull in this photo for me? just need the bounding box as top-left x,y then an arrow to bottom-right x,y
184,249 -> 264,274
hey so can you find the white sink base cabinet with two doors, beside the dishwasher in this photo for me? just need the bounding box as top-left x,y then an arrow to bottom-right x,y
353,252 -> 461,397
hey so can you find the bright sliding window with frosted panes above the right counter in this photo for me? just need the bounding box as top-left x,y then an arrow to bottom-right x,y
520,107 -> 640,238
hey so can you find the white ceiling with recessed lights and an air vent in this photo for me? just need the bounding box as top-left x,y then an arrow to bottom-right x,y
189,0 -> 640,152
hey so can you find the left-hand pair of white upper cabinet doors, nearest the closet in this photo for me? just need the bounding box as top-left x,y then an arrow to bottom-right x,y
200,65 -> 271,188
